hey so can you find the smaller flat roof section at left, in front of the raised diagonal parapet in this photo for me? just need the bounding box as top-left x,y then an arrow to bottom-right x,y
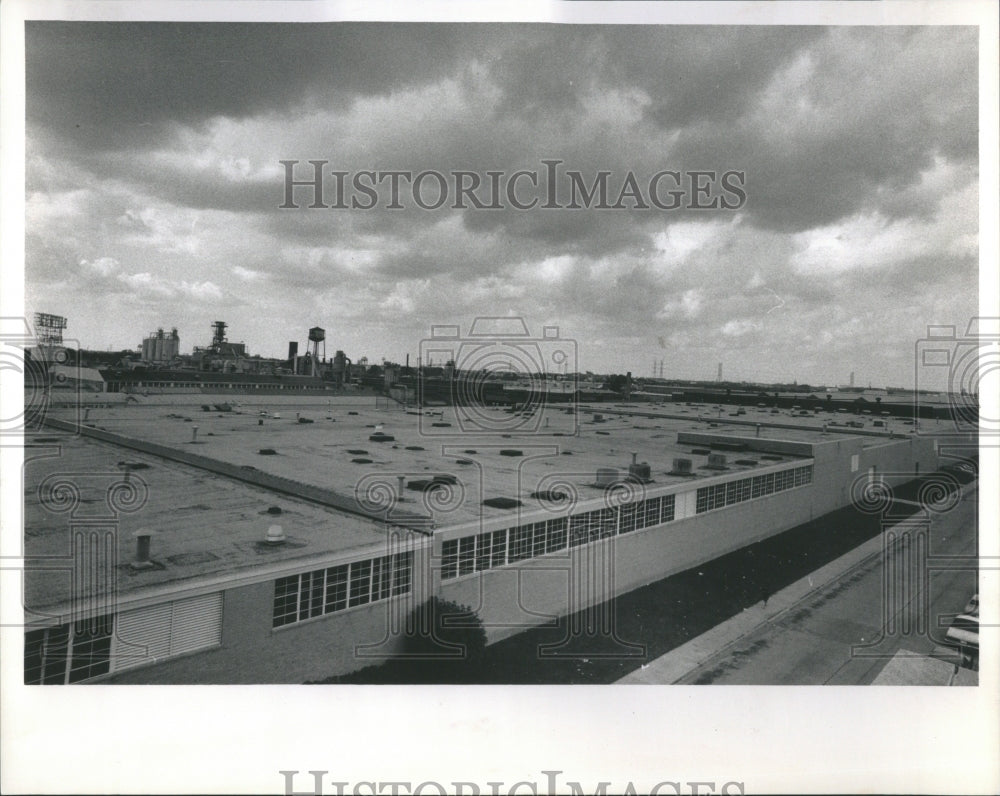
24,429 -> 414,608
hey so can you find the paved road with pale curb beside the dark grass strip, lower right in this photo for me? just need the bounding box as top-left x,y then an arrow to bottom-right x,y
622,483 -> 977,685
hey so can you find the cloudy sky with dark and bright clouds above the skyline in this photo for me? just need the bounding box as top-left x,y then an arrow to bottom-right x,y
25,22 -> 979,386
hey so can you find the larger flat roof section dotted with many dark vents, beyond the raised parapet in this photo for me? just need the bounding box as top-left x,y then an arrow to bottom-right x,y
37,395 -> 844,528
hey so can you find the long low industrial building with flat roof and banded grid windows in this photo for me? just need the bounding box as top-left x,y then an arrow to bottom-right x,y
25,395 -> 971,683
